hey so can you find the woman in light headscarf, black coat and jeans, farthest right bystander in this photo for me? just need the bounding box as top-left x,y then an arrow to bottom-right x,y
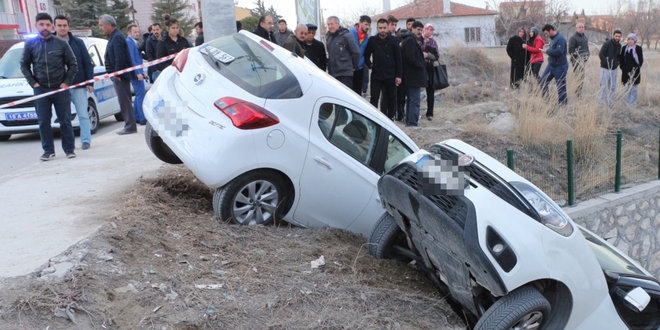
619,33 -> 644,107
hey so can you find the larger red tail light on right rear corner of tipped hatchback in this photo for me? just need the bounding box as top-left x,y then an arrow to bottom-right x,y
213,97 -> 280,129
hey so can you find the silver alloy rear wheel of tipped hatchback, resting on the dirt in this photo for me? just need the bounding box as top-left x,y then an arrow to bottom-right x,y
213,172 -> 291,225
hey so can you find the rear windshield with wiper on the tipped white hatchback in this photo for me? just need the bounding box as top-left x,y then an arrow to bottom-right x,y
200,34 -> 302,99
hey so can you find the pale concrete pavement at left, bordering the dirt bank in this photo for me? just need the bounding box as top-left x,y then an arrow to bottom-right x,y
0,126 -> 164,277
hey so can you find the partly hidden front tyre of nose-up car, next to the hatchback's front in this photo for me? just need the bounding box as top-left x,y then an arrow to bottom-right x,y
368,212 -> 415,262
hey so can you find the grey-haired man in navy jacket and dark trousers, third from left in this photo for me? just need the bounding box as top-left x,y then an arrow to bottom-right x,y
99,15 -> 137,135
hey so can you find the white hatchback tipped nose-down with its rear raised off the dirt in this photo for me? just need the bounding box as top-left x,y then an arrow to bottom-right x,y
144,31 -> 418,236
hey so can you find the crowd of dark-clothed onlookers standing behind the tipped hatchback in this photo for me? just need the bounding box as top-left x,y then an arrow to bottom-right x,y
252,15 -> 439,126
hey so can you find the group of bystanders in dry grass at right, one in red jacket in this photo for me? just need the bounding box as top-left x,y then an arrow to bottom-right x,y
506,20 -> 644,108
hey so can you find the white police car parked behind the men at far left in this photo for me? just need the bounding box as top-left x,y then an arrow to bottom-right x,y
0,37 -> 122,141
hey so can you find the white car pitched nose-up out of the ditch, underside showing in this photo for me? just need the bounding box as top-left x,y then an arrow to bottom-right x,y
369,140 -> 660,330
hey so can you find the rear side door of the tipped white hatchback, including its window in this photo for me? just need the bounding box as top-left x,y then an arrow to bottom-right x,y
294,99 -> 383,235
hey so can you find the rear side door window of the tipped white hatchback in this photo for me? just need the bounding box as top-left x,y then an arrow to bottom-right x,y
318,103 -> 379,166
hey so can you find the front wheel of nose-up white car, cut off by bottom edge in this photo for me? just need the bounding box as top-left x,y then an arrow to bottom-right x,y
474,287 -> 551,330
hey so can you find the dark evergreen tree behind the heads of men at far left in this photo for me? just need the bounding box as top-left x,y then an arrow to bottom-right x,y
57,0 -> 129,37
